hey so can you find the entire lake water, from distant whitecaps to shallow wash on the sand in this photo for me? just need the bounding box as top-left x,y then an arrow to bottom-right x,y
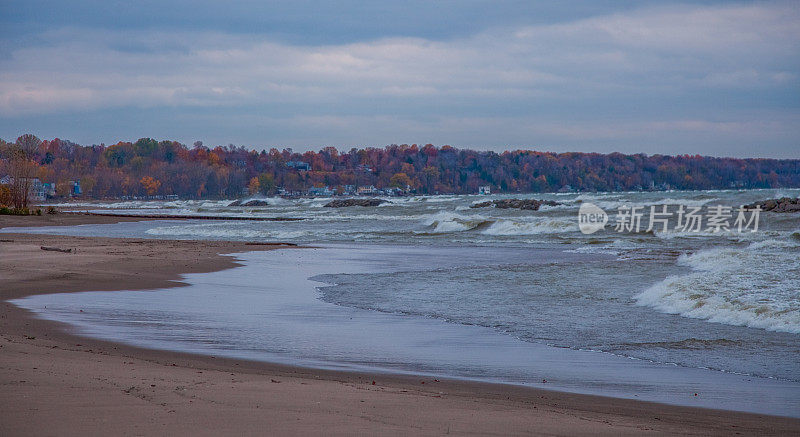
6,190 -> 800,416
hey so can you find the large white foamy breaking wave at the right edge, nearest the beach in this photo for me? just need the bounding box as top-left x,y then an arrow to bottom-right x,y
635,236 -> 800,334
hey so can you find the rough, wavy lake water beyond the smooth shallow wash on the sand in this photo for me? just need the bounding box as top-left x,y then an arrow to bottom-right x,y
7,190 -> 800,410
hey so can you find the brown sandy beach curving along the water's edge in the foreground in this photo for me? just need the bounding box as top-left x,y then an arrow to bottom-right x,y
0,215 -> 800,436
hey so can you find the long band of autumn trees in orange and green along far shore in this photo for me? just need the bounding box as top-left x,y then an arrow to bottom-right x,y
0,134 -> 800,203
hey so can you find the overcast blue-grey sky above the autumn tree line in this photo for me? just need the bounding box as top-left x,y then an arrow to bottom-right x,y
0,0 -> 800,158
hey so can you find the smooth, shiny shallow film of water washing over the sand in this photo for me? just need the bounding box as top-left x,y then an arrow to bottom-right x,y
13,246 -> 800,416
